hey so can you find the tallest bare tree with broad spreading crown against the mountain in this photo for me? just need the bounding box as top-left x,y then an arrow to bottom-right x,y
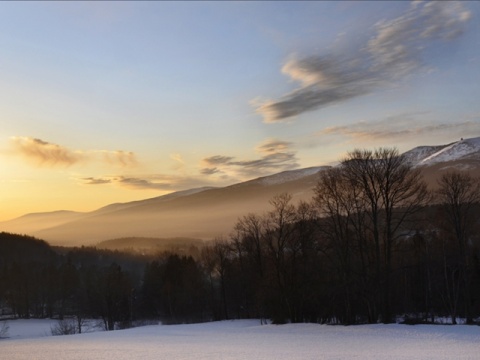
342,148 -> 429,322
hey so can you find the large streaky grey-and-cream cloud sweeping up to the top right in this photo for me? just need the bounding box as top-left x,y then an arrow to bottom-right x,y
256,1 -> 471,123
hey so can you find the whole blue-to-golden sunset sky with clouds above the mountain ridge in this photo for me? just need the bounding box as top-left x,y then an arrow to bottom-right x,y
0,1 -> 480,221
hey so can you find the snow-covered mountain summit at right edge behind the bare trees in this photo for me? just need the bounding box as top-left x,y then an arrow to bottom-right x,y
404,137 -> 480,166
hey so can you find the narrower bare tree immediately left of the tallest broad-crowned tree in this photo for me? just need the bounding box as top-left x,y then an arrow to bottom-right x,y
314,167 -> 376,324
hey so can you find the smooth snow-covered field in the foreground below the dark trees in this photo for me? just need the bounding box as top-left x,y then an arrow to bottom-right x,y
0,320 -> 480,360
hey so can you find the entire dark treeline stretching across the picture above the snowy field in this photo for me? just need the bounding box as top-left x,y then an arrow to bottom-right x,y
0,149 -> 480,330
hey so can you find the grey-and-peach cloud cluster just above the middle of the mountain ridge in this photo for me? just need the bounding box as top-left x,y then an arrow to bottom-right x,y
201,139 -> 299,178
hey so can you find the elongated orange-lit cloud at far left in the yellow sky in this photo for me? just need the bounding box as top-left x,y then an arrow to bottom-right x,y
10,136 -> 137,167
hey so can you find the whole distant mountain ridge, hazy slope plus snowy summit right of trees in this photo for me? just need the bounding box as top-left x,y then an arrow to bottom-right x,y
0,138 -> 480,248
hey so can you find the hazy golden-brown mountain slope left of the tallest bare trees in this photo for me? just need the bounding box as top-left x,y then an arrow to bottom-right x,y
0,167 -> 327,246
